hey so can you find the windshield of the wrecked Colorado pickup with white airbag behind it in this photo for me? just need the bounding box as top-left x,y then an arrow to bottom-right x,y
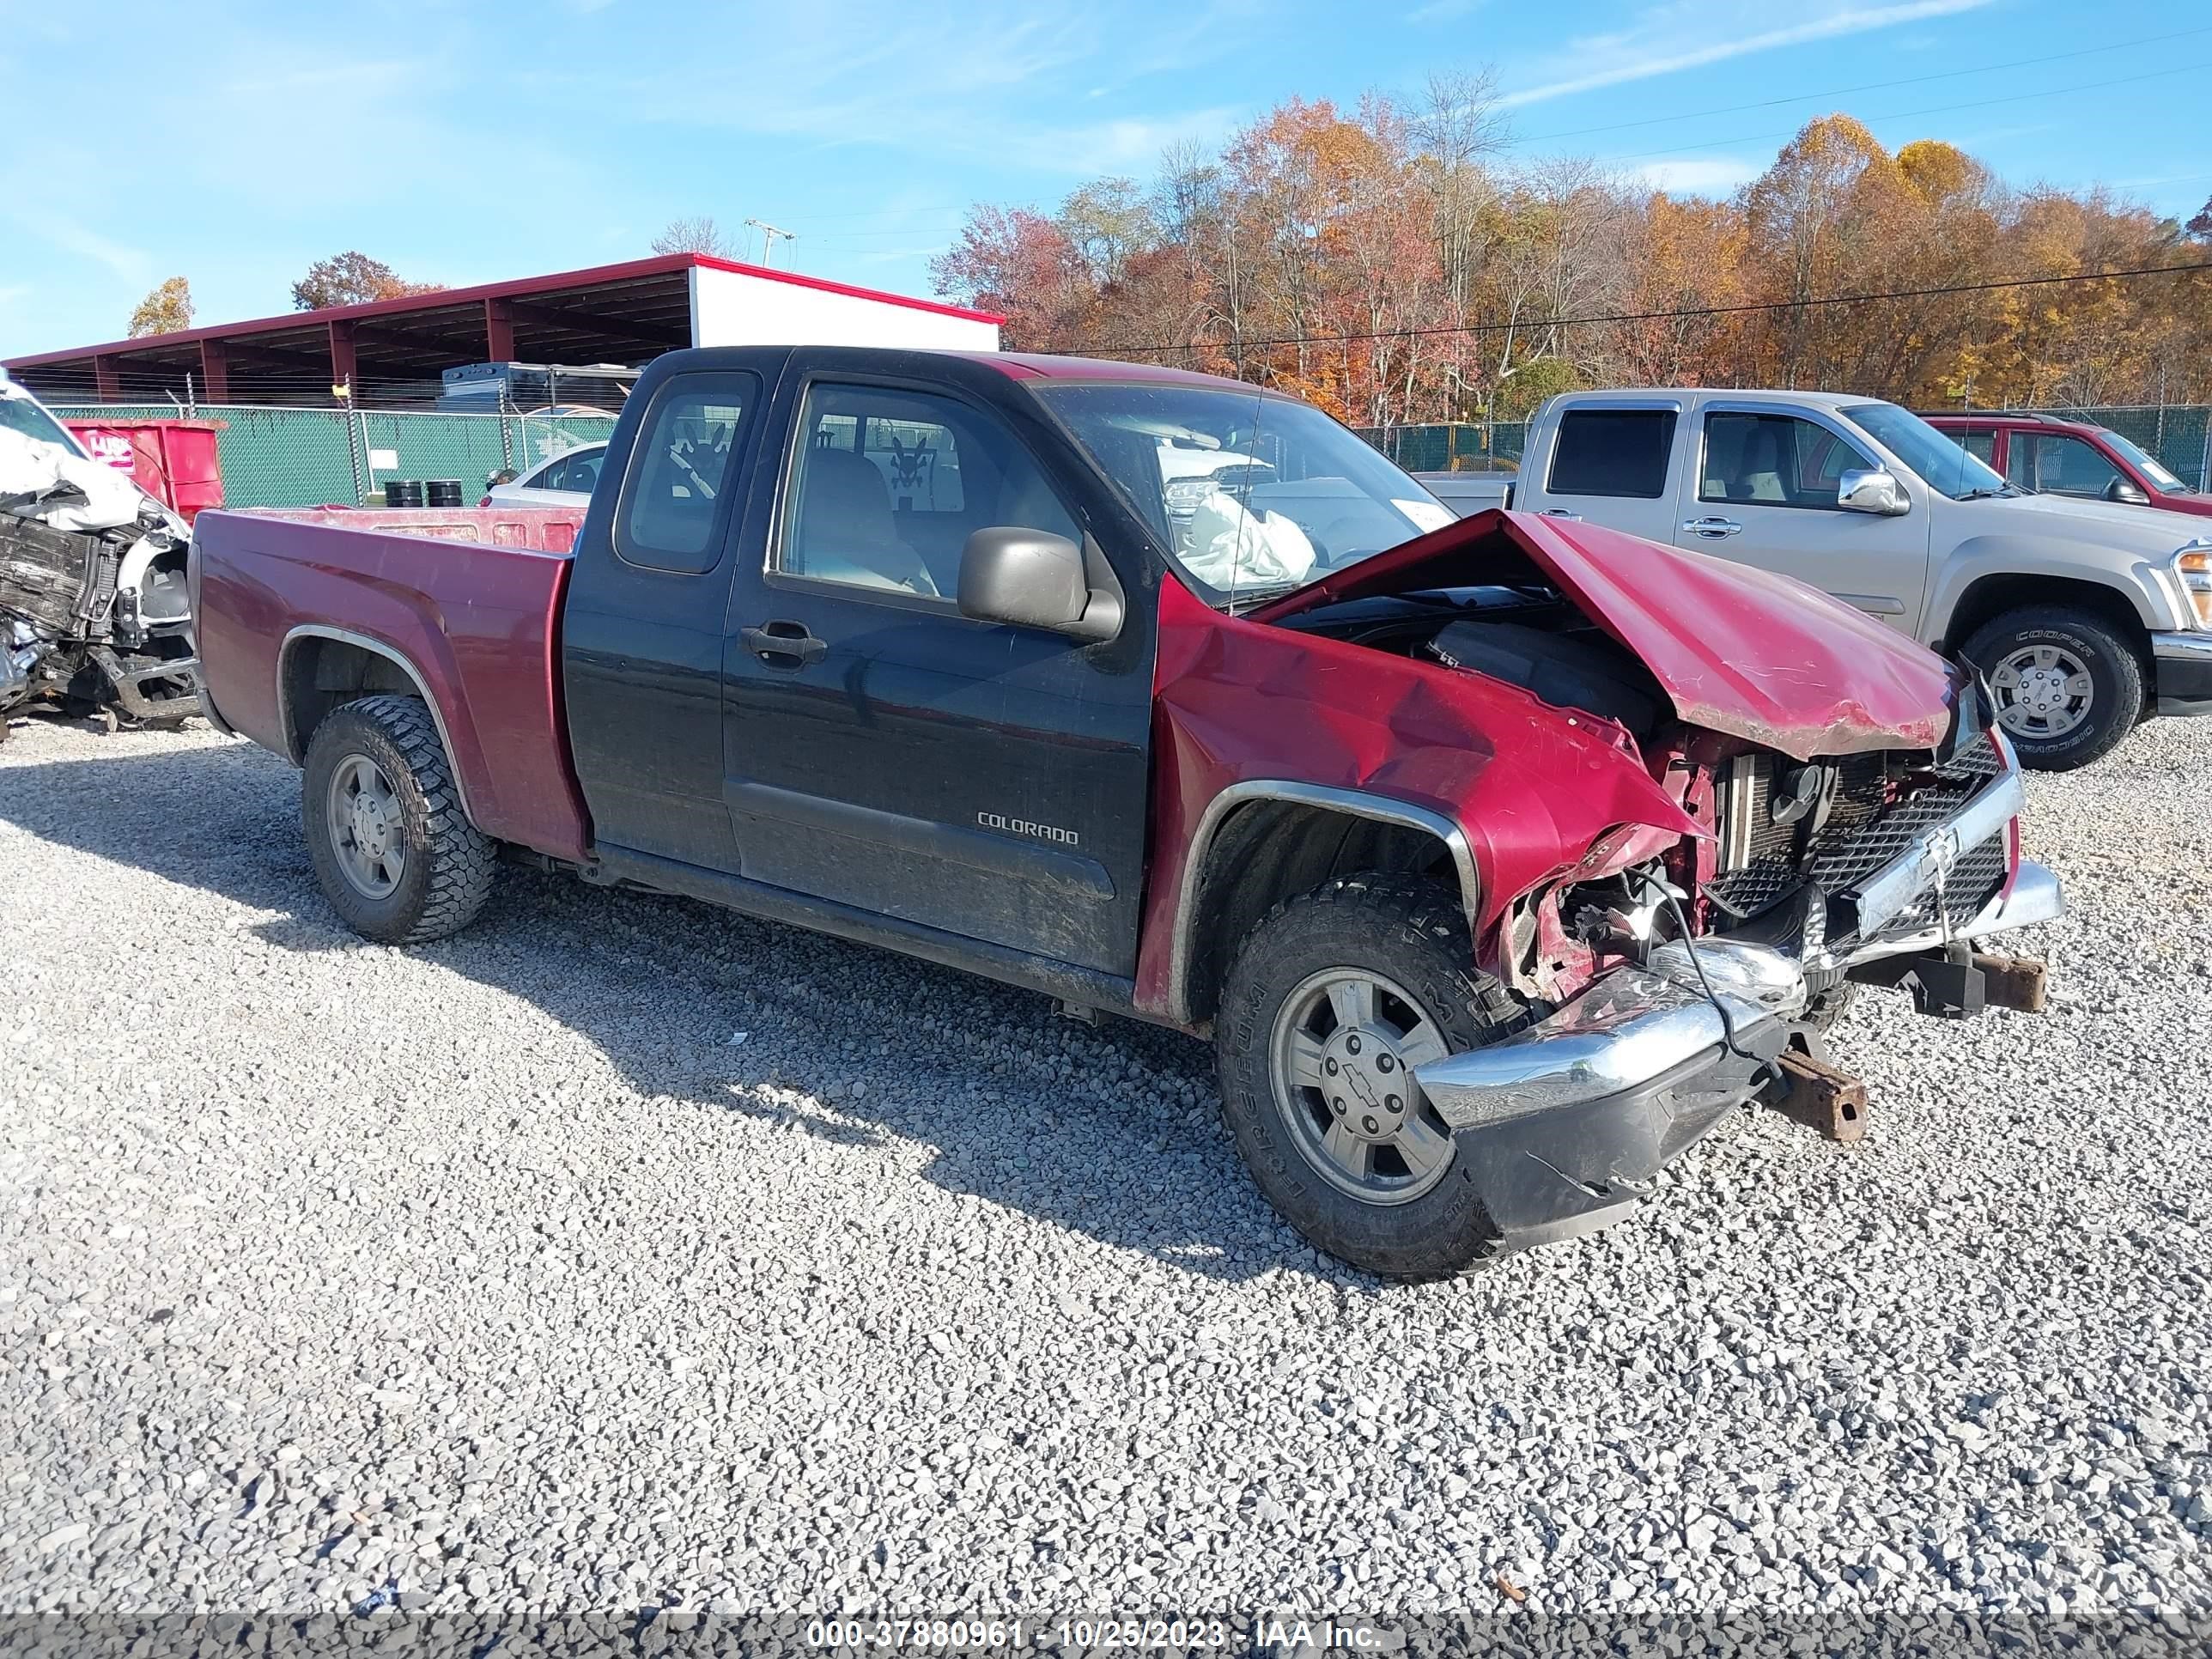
1033,385 -> 1453,606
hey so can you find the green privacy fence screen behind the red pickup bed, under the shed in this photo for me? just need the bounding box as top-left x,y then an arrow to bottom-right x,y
53,403 -> 615,507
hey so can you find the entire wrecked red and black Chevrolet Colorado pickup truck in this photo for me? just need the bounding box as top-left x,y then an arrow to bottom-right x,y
191,347 -> 2059,1276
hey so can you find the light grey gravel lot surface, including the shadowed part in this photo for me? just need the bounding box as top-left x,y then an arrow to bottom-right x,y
0,721 -> 2212,1654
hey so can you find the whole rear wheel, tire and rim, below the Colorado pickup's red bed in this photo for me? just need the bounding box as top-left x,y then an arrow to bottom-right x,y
301,696 -> 498,945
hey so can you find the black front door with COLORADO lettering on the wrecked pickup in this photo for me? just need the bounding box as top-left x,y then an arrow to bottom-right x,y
723,374 -> 1152,975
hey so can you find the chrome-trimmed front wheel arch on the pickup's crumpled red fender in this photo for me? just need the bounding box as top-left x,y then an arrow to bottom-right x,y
1168,779 -> 1482,1026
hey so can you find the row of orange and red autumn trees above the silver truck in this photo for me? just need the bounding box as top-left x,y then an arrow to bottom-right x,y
931,91 -> 2212,427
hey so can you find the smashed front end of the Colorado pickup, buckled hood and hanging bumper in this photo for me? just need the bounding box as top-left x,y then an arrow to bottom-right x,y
1256,515 -> 2059,1248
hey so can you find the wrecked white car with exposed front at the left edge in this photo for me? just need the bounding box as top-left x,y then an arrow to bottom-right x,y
0,374 -> 199,741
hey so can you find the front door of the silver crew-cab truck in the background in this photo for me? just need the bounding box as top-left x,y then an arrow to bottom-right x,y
1674,403 -> 1929,633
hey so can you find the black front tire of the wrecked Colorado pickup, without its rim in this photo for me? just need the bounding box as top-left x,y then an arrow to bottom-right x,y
1214,874 -> 1528,1281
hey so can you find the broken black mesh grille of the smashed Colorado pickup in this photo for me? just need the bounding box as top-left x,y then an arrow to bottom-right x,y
1705,734 -> 2006,942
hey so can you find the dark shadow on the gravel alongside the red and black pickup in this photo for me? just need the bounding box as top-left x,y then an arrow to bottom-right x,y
0,744 -> 1327,1287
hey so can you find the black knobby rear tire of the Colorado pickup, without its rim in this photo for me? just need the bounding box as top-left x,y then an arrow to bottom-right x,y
301,695 -> 498,945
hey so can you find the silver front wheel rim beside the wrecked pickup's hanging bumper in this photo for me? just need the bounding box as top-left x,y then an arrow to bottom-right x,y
1267,967 -> 1451,1203
